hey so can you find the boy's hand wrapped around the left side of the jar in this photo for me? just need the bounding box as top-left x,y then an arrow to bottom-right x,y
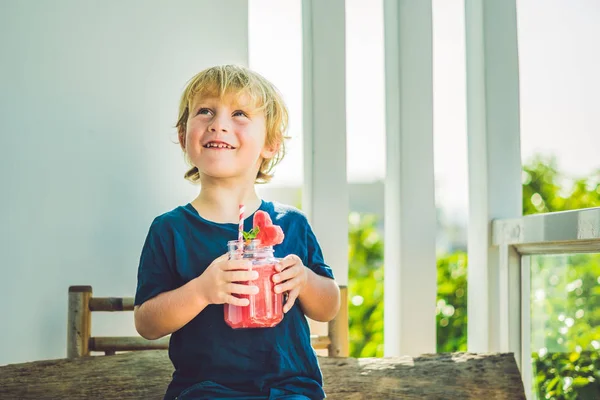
195,254 -> 258,306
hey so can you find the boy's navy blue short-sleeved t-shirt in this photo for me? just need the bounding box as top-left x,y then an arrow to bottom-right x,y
135,201 -> 333,399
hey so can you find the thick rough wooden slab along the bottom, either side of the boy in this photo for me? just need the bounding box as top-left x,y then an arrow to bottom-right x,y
0,350 -> 525,400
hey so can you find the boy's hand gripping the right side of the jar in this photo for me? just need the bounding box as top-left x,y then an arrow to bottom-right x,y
273,254 -> 308,313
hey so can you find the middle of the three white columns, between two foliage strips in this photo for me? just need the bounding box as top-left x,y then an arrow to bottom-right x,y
384,0 -> 437,356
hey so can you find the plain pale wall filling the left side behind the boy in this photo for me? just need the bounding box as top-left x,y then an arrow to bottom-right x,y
0,0 -> 248,365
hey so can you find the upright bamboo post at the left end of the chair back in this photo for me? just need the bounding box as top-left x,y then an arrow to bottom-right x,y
67,286 -> 92,358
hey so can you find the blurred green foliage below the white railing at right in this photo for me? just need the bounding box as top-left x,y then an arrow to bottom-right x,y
531,254 -> 600,400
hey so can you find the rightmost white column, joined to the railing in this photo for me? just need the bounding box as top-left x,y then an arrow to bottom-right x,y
465,0 -> 522,352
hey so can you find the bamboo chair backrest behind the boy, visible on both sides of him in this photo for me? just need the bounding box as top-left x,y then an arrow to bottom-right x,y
67,286 -> 349,358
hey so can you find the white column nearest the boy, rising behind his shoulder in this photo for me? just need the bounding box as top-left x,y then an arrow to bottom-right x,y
302,0 -> 349,285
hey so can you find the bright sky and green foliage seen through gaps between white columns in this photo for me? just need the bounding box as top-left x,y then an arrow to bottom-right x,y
249,0 -> 600,399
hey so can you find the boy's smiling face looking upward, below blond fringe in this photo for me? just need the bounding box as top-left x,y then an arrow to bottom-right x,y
180,95 -> 276,182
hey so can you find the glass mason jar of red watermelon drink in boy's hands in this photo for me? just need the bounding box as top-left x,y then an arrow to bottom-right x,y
224,240 -> 283,329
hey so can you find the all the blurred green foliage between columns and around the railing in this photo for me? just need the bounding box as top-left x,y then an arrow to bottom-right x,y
349,157 -> 600,400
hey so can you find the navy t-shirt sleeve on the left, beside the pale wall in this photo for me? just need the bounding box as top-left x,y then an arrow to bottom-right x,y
134,219 -> 178,306
